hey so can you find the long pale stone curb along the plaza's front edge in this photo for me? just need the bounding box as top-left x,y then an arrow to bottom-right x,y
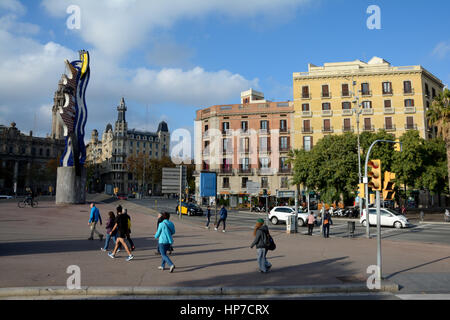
0,280 -> 400,300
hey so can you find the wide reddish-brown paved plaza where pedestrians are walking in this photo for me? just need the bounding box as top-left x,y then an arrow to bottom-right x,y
0,201 -> 450,298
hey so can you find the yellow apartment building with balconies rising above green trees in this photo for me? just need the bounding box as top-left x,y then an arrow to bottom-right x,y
293,57 -> 444,150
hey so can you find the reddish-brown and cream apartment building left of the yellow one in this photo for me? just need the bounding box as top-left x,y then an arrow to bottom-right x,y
196,89 -> 295,205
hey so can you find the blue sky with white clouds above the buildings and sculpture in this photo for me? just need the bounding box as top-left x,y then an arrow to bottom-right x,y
0,0 -> 450,139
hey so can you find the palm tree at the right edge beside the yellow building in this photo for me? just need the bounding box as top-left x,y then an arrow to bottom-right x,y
427,88 -> 450,187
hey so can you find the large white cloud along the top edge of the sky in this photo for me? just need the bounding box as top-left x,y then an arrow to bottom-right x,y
42,0 -> 310,58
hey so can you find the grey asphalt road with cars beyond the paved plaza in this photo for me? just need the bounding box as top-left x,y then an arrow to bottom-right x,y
129,198 -> 450,245
